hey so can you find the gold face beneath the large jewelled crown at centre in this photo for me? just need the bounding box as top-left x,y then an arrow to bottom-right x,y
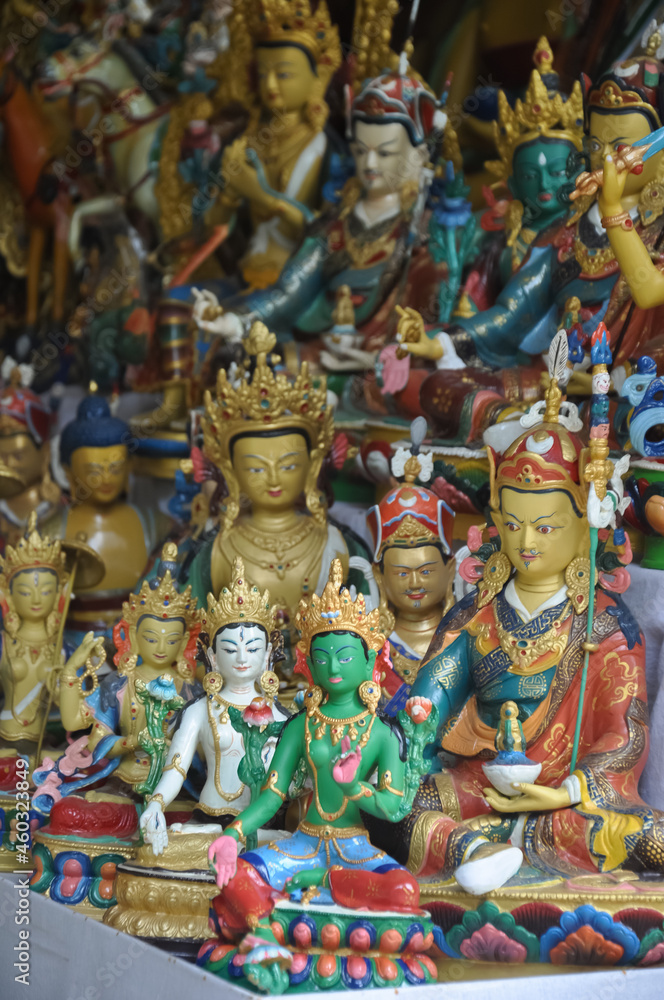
233,434 -> 309,512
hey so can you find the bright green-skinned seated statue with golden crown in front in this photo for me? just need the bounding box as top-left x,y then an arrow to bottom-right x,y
199,560 -> 521,992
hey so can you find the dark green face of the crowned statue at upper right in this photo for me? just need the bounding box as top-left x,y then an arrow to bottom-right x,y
509,139 -> 575,220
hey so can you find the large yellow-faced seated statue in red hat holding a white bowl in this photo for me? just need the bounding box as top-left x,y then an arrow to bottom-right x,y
368,336 -> 664,884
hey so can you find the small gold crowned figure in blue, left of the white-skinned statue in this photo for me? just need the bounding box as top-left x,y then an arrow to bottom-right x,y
56,542 -> 201,794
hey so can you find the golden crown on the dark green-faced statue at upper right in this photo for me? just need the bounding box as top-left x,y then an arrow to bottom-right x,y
486,35 -> 583,180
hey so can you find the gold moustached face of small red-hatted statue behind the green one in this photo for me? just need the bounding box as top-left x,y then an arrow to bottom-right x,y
383,545 -> 454,614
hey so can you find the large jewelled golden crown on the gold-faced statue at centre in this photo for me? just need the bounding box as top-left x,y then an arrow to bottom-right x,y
202,322 -> 334,465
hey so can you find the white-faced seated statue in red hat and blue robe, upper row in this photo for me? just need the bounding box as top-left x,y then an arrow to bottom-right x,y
195,60 -> 456,354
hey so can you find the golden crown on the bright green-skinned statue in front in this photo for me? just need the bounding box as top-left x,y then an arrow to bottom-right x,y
295,559 -> 385,654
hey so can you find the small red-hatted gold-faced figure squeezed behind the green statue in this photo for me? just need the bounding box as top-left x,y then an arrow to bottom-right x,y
367,417 -> 456,700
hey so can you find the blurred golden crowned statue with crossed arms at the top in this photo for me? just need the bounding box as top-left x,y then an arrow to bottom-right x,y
160,0 -> 341,288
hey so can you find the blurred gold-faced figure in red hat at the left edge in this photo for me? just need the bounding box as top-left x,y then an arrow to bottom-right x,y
0,359 -> 63,545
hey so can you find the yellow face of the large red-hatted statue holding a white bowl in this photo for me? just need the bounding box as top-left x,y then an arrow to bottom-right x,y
494,488 -> 589,581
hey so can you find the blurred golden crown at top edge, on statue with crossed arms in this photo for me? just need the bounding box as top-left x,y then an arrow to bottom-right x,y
245,0 -> 341,79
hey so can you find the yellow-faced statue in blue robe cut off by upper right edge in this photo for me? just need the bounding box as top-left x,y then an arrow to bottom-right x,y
386,37 -> 664,438
